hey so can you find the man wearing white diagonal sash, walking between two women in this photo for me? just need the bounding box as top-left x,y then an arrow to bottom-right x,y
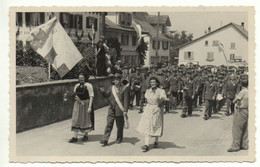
100,74 -> 129,146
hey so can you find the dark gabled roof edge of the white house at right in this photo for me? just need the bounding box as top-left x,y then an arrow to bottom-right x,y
175,22 -> 248,49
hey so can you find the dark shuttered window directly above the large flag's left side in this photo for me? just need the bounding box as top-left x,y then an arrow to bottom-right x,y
25,12 -> 45,27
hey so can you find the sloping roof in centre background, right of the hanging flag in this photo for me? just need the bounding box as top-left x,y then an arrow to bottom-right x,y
135,20 -> 171,40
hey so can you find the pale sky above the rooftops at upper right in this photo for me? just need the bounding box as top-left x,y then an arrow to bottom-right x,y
149,12 -> 248,39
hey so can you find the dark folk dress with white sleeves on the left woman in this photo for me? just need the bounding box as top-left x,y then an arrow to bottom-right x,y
71,83 -> 94,132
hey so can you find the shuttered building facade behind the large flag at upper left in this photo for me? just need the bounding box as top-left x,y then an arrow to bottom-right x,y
16,12 -> 106,44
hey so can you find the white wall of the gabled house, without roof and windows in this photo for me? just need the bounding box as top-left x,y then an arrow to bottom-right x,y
179,26 -> 248,65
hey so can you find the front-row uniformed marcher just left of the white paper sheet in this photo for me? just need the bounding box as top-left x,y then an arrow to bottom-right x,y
203,74 -> 217,120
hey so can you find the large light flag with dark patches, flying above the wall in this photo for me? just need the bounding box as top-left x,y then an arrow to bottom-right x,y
30,17 -> 83,77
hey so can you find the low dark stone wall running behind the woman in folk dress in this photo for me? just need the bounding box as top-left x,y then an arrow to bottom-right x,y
16,77 -> 111,132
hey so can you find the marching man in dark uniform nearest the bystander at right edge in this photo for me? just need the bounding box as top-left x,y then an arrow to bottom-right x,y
223,73 -> 239,116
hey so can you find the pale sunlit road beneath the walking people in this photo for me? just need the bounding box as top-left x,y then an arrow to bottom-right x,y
16,104 -> 248,156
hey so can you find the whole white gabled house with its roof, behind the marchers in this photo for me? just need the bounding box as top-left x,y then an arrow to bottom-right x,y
177,23 -> 248,65
